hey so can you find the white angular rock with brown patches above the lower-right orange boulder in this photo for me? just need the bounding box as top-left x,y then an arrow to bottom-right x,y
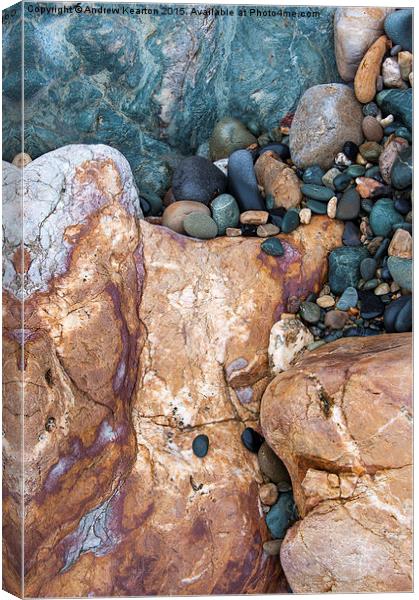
268,319 -> 314,374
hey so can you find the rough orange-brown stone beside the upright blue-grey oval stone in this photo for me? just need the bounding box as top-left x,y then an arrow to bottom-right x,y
255,151 -> 302,209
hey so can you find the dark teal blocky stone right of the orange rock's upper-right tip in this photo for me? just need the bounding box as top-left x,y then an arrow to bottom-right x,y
329,246 -> 369,294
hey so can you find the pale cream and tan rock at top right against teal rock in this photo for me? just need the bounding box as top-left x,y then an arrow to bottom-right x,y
335,6 -> 394,81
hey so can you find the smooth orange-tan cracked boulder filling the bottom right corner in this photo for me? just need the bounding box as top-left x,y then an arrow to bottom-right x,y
261,334 -> 412,593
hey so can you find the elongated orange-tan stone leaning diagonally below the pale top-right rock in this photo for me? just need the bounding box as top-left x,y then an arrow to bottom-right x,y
354,35 -> 391,104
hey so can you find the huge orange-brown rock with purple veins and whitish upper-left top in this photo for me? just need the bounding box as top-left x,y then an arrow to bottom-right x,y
3,146 -> 342,597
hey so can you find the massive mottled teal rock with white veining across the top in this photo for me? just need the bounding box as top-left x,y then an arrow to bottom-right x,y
3,3 -> 339,193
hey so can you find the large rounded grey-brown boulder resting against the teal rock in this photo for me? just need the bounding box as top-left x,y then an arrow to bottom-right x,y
290,83 -> 364,169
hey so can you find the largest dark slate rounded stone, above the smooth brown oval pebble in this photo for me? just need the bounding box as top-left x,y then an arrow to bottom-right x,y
172,156 -> 227,204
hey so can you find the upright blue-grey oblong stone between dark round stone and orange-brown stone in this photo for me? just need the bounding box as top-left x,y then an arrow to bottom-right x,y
228,150 -> 266,211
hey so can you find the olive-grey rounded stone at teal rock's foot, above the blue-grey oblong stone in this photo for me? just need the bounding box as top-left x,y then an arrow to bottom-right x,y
209,117 -> 257,160
